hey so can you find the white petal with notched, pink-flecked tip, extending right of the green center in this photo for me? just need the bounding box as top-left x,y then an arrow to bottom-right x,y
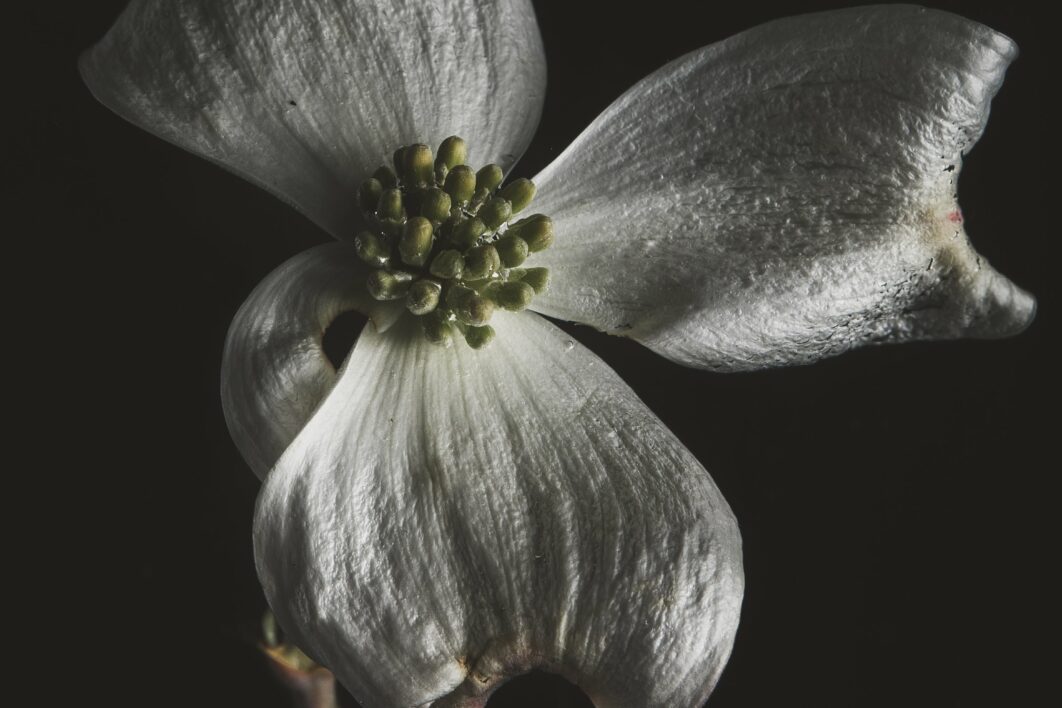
535,5 -> 1034,370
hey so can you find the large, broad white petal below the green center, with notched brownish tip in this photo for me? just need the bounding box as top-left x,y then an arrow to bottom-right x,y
255,313 -> 743,707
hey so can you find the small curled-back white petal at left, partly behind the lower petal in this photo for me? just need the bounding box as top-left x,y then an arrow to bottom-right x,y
221,243 -> 404,479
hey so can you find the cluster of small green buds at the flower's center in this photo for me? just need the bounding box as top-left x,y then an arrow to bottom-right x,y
354,136 -> 553,349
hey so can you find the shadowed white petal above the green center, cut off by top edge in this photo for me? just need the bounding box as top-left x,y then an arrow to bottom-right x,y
81,0 -> 546,238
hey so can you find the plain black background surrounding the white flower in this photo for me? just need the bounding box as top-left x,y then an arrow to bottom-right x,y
20,0 -> 1058,708
